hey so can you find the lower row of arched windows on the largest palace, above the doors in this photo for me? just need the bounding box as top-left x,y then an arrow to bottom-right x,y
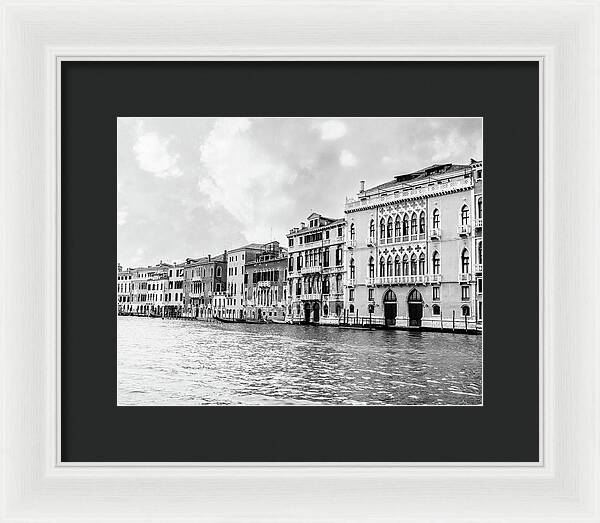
350,249 -> 474,279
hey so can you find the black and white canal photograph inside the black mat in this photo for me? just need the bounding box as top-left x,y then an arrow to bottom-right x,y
115,117 -> 484,407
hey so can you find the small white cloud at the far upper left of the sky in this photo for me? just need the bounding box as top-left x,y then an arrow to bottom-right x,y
133,123 -> 183,178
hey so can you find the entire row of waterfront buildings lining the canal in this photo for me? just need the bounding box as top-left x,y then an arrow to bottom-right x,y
117,160 -> 483,329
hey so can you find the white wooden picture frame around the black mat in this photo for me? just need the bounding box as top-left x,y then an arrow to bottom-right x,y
0,0 -> 600,523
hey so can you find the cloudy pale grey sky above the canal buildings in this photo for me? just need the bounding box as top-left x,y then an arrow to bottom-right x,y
117,118 -> 483,267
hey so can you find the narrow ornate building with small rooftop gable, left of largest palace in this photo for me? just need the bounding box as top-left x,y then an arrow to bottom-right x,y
287,213 -> 346,324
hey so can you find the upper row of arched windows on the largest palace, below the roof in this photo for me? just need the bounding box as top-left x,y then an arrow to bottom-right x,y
350,203 -> 483,240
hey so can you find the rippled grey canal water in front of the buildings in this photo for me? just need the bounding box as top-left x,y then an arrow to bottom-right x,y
117,316 -> 482,405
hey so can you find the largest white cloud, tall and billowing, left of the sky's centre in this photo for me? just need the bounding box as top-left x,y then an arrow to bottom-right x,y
198,118 -> 296,242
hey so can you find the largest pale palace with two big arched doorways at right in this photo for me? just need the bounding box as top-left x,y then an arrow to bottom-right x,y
345,160 -> 483,330
